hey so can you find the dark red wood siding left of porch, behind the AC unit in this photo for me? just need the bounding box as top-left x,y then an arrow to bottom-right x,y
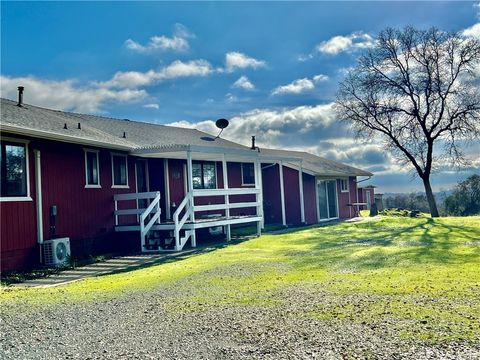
1,139 -> 141,270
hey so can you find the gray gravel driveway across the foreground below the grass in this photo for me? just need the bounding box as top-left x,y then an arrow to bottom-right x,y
0,277 -> 480,360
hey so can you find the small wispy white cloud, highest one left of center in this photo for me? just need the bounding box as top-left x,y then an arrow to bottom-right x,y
125,24 -> 194,53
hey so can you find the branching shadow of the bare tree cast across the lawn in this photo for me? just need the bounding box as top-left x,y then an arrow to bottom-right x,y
286,218 -> 480,269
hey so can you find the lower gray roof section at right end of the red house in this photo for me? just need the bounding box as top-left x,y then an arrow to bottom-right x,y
260,149 -> 373,176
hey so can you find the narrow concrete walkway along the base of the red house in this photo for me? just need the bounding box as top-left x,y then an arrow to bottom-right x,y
12,249 -> 198,287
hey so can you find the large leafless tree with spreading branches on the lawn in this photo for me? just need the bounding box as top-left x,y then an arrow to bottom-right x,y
336,27 -> 480,217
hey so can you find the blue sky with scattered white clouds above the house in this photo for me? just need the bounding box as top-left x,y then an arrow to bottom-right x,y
1,2 -> 480,191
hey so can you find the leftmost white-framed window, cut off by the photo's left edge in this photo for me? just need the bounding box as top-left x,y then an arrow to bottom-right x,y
0,141 -> 29,198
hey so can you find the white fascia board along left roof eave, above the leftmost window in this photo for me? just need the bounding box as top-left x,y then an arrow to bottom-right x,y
0,124 -> 132,151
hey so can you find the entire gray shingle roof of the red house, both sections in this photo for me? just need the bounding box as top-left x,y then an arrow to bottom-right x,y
0,99 -> 372,176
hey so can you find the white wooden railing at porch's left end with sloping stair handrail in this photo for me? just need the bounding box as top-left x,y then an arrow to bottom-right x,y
113,191 -> 161,251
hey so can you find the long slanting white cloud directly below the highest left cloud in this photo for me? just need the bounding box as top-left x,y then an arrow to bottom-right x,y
101,60 -> 213,88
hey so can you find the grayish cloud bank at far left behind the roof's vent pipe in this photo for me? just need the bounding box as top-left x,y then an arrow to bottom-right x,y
0,76 -> 147,113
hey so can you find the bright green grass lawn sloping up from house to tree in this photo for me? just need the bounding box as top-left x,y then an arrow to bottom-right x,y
0,217 -> 480,343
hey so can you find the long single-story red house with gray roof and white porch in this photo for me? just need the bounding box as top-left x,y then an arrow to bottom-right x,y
0,94 -> 373,271
